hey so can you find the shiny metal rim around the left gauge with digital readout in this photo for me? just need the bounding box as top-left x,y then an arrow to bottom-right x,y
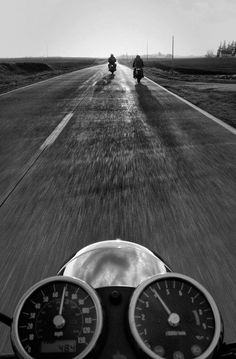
11,276 -> 103,359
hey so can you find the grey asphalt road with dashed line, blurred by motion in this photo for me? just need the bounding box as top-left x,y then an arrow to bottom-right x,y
0,65 -> 236,350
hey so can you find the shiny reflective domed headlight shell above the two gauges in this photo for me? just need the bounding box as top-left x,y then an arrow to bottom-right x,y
58,239 -> 170,288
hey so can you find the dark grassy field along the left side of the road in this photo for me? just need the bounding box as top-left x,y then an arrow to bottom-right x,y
0,57 -> 104,93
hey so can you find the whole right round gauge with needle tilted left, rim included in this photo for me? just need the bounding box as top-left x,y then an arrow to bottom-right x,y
129,273 -> 222,359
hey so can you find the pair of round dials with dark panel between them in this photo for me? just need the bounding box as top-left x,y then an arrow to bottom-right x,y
11,273 -> 222,359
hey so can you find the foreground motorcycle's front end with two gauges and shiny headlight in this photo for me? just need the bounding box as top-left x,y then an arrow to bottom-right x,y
0,240 -> 236,359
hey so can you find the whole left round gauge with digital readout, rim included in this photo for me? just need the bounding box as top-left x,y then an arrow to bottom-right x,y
12,277 -> 102,359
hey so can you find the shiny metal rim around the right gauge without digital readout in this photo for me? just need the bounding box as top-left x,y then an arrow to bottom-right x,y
128,272 -> 223,359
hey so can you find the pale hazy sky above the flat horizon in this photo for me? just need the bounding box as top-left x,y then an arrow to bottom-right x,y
0,0 -> 236,57
